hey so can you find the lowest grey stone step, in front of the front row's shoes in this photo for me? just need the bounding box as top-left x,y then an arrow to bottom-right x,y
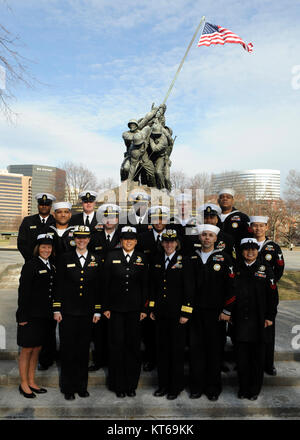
0,386 -> 300,424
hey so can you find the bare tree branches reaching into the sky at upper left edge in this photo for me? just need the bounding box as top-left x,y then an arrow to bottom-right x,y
0,18 -> 33,121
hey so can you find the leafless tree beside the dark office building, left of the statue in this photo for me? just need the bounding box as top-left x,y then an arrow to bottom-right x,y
60,162 -> 99,204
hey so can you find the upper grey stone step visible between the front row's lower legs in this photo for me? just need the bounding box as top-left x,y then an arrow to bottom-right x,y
0,360 -> 300,386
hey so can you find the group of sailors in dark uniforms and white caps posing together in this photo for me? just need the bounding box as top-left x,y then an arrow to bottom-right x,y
16,188 -> 284,401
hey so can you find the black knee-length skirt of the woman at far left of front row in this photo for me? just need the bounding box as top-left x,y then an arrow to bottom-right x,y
17,318 -> 51,348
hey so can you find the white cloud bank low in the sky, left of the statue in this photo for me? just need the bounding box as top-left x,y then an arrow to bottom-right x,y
0,105 -> 124,181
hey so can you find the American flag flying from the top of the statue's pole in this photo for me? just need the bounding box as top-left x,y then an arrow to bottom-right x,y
198,23 -> 253,52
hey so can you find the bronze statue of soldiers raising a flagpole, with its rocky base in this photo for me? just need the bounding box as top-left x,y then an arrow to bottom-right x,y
98,17 -> 205,207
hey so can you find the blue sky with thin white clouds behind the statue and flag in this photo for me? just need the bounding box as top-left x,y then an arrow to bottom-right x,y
0,0 -> 300,193
